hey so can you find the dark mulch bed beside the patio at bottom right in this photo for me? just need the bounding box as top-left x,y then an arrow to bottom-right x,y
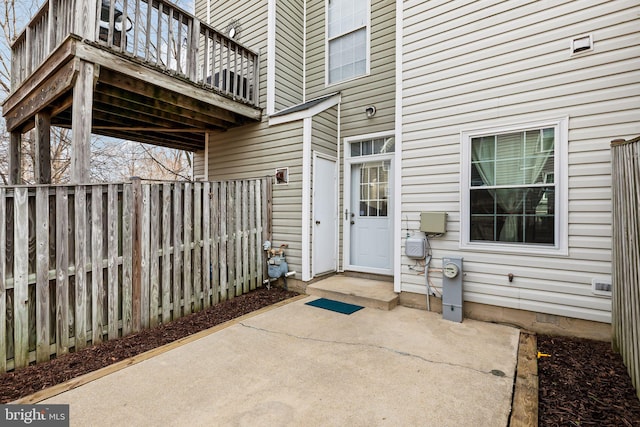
538,336 -> 640,427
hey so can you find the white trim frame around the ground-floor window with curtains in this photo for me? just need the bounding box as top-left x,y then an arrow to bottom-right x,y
460,117 -> 569,256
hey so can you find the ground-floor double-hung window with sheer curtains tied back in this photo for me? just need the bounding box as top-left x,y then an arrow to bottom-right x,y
461,120 -> 567,252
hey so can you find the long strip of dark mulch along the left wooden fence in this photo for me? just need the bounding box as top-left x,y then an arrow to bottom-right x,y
0,287 -> 297,403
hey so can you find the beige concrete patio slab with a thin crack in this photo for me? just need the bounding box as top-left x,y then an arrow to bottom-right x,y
40,297 -> 518,427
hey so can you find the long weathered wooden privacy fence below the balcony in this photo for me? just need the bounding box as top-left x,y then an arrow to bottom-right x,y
0,178 -> 271,372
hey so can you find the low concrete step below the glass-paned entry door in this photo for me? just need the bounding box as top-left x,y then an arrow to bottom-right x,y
307,276 -> 398,310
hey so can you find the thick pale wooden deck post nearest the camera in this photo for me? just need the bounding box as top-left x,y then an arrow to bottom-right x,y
71,61 -> 96,184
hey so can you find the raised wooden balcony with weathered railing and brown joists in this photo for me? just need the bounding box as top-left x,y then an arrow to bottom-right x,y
3,0 -> 261,181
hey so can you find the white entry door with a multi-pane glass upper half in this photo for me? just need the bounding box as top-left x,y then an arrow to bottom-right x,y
348,158 -> 393,273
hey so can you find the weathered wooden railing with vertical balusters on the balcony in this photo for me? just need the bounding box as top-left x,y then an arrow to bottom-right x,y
11,0 -> 259,105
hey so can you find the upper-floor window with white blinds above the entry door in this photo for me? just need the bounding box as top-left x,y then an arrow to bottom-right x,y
327,0 -> 369,84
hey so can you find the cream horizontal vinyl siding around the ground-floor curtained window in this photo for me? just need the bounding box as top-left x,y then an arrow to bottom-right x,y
401,0 -> 640,322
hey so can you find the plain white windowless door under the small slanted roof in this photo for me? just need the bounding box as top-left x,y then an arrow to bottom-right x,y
312,154 -> 337,276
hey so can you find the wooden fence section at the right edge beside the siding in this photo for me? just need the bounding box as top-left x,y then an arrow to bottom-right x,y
611,137 -> 640,398
